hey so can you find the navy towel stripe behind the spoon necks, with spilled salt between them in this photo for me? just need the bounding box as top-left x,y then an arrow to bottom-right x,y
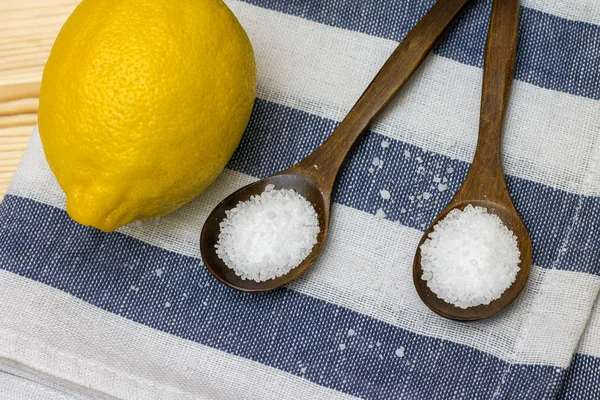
228,100 -> 600,274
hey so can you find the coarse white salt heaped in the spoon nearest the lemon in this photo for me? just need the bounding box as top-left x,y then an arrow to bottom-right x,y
215,185 -> 320,282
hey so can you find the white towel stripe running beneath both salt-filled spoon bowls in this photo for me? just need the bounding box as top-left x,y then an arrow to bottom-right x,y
5,135 -> 600,367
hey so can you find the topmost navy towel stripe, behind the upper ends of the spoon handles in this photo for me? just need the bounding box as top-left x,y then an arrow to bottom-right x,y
244,0 -> 600,100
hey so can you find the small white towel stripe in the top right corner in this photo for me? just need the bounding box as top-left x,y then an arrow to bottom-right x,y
521,0 -> 600,25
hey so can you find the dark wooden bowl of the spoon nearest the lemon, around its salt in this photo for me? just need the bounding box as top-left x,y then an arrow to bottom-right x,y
200,172 -> 330,292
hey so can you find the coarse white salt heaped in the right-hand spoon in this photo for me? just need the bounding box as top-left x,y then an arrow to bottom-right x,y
421,205 -> 521,308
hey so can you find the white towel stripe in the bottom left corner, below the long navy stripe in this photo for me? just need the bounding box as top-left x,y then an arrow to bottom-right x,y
0,271 -> 353,400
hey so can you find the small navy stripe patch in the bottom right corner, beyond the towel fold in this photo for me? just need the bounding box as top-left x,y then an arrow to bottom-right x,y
556,354 -> 600,400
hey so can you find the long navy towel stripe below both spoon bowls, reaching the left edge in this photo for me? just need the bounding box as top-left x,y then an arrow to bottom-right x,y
0,195 -> 564,400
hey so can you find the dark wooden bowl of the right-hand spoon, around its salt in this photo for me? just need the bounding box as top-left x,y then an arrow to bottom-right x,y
413,200 -> 531,321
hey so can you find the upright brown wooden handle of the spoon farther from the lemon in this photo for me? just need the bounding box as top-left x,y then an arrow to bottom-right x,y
465,0 -> 519,200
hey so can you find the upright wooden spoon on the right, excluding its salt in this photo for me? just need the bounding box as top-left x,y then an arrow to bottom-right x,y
413,0 -> 531,321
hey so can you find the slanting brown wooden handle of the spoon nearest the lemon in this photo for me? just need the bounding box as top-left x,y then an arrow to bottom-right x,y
292,0 -> 471,191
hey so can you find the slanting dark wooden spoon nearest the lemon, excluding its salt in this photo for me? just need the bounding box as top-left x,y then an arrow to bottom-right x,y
200,0 -> 471,292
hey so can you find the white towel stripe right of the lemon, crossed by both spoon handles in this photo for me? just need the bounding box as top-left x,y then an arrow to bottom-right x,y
228,0 -> 600,195
